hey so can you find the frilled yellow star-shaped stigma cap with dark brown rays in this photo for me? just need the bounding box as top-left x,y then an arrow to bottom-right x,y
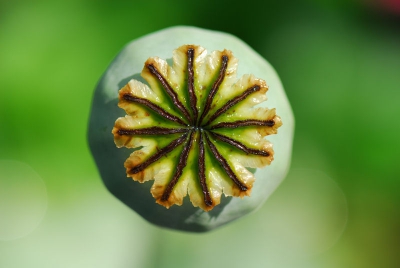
112,45 -> 282,211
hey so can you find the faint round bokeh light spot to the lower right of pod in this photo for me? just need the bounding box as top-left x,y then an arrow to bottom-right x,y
264,169 -> 348,259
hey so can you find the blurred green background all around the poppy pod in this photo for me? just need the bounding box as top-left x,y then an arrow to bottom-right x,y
0,0 -> 400,268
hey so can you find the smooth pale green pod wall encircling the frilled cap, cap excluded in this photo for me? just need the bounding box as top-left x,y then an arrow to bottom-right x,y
88,26 -> 294,232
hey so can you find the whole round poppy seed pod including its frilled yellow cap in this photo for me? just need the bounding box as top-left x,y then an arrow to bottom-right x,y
88,27 -> 294,232
